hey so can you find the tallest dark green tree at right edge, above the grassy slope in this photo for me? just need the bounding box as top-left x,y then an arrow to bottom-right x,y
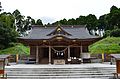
101,6 -> 120,35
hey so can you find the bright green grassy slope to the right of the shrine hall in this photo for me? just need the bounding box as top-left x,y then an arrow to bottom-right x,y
89,37 -> 120,54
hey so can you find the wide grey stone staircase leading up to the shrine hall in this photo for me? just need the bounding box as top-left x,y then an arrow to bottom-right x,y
6,65 -> 115,79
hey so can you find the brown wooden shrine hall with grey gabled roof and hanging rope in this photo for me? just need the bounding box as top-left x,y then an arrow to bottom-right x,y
19,25 -> 100,64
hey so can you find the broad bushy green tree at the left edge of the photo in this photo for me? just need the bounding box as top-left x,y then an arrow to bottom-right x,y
0,12 -> 18,49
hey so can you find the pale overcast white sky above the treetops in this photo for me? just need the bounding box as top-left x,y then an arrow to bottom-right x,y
0,0 -> 120,24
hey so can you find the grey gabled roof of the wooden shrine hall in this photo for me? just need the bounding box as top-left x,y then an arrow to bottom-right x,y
20,25 -> 99,39
